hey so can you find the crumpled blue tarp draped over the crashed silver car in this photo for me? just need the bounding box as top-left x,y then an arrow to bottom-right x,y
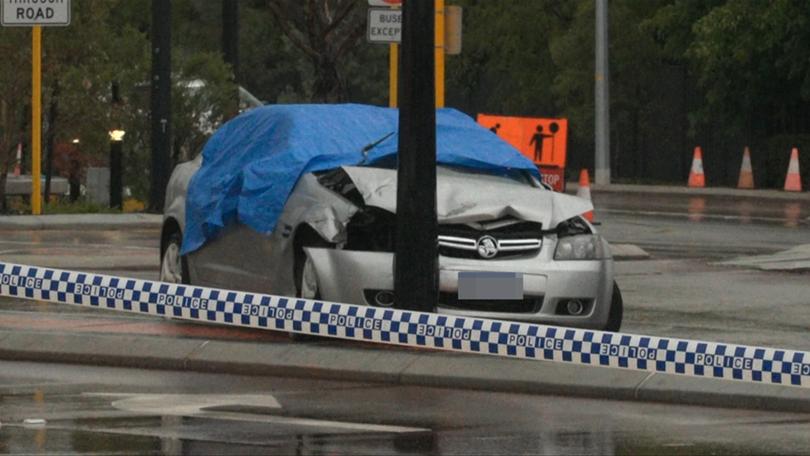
182,104 -> 540,254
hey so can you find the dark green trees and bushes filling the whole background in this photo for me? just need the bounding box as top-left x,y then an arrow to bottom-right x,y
0,0 -> 810,205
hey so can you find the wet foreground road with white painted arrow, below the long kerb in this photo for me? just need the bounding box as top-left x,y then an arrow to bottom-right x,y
0,362 -> 810,455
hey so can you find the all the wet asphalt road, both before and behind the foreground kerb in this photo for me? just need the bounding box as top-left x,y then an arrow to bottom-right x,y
0,191 -> 810,454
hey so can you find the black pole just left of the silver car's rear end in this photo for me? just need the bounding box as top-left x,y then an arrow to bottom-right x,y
149,0 -> 172,212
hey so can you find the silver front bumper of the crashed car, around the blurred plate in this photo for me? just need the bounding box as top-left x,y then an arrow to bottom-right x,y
305,238 -> 613,329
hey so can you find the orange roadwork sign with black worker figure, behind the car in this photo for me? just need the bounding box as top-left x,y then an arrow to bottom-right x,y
478,114 -> 568,169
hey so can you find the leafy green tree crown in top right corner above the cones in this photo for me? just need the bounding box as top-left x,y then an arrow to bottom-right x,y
687,0 -> 810,133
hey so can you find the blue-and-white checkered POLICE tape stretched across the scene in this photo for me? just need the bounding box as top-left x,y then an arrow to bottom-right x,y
0,263 -> 810,387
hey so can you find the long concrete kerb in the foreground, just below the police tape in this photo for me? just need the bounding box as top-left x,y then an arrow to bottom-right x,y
0,330 -> 810,412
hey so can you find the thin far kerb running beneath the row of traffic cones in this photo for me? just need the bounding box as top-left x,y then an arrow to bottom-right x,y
565,183 -> 810,202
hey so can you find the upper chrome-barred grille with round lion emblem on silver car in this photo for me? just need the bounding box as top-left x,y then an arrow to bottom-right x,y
439,221 -> 543,259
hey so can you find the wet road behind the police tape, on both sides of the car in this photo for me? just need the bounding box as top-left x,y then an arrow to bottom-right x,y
0,189 -> 810,350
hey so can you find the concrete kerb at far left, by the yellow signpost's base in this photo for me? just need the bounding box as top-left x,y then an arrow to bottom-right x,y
0,214 -> 163,230
